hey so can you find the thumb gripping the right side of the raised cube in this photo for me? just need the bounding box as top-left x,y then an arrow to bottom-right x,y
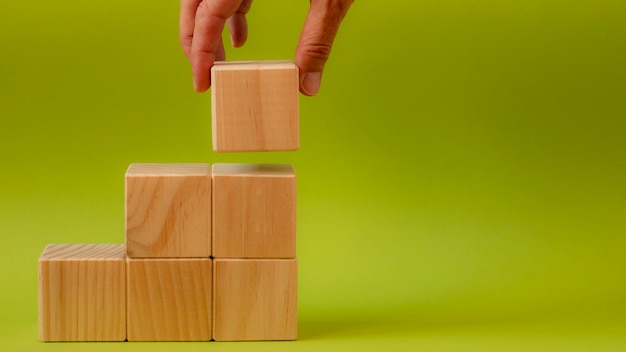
296,0 -> 354,95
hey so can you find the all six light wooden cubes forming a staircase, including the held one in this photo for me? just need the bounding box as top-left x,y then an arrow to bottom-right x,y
39,61 -> 299,341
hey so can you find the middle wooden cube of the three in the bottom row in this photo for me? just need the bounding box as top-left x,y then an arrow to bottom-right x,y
127,258 -> 212,341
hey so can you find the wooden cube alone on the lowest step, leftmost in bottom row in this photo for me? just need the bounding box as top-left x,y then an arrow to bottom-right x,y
39,244 -> 126,341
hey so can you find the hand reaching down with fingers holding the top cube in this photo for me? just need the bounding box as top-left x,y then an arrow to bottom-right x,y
180,0 -> 354,96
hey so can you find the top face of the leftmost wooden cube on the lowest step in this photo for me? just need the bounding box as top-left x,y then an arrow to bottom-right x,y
39,244 -> 126,261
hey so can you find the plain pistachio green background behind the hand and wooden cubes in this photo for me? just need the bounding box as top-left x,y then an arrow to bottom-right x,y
0,0 -> 626,351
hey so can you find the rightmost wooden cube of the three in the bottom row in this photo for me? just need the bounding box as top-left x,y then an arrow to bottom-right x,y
213,259 -> 298,341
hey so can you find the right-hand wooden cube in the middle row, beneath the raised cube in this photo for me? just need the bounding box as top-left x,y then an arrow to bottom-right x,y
212,164 -> 296,258
